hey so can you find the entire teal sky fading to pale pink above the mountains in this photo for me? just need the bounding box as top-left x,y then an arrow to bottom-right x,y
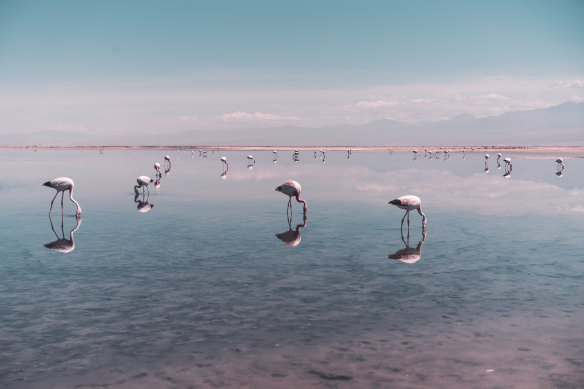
0,0 -> 584,141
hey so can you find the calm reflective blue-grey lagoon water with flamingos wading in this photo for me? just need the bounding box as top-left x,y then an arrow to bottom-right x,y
0,150 -> 584,388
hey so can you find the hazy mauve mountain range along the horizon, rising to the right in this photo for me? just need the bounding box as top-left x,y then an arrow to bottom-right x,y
0,102 -> 584,146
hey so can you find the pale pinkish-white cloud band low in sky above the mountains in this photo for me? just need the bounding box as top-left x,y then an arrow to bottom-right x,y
0,72 -> 584,135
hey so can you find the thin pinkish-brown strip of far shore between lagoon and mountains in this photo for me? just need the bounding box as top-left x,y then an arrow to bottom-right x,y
0,145 -> 584,156
